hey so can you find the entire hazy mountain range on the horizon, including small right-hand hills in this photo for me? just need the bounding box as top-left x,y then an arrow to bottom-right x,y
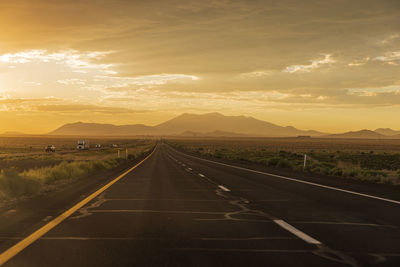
43,112 -> 400,139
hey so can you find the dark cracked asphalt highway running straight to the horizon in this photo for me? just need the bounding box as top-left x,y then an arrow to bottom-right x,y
0,143 -> 400,267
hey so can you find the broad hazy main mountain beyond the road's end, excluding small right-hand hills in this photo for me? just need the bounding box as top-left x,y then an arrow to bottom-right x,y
50,113 -> 323,136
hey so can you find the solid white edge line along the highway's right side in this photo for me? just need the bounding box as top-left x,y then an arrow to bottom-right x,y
175,150 -> 400,205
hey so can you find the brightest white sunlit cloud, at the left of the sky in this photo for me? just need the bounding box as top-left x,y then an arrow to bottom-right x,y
0,47 -> 200,101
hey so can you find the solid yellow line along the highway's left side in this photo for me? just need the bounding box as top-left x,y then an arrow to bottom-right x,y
0,148 -> 155,266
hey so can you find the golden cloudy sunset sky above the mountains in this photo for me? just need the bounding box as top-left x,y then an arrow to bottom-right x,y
0,0 -> 400,134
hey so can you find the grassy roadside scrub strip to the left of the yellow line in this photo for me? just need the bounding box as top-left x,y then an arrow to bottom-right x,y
0,140 -> 155,206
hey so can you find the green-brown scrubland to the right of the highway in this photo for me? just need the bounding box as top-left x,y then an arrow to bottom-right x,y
170,138 -> 400,185
